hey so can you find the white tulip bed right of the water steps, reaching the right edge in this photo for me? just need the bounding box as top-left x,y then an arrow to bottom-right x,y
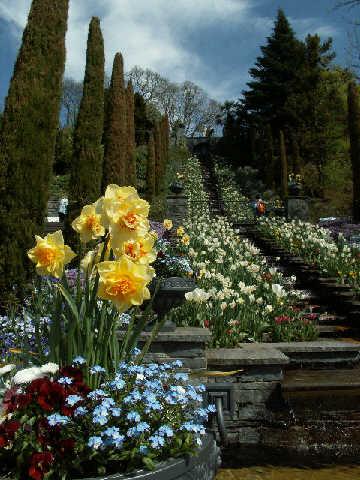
259,218 -> 360,292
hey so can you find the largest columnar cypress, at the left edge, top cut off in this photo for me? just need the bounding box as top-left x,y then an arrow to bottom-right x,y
0,0 -> 69,299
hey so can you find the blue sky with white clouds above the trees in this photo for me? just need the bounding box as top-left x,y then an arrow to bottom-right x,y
0,0 -> 360,108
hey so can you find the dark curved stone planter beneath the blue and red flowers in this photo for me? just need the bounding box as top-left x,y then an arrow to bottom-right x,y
81,434 -> 219,480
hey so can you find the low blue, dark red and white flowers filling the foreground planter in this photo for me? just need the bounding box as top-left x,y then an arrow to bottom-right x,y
0,357 -> 214,480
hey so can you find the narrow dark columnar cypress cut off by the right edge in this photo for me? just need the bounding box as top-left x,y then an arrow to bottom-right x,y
348,82 -> 360,222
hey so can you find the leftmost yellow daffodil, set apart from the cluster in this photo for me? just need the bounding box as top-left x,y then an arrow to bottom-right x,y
28,230 -> 76,278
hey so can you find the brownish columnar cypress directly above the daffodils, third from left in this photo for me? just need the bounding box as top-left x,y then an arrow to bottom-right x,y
103,53 -> 128,190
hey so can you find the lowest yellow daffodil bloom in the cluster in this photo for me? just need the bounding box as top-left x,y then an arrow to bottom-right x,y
97,256 -> 155,312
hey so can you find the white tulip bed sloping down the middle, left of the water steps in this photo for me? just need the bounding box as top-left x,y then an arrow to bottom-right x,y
166,158 -> 317,347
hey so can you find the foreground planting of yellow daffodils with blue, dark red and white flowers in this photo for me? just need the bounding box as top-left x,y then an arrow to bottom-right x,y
0,185 -> 213,480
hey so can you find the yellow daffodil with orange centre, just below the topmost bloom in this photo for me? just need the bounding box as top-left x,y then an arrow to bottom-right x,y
108,197 -> 150,248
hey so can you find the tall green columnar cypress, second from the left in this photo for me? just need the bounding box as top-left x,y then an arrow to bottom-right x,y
69,17 -> 104,206
